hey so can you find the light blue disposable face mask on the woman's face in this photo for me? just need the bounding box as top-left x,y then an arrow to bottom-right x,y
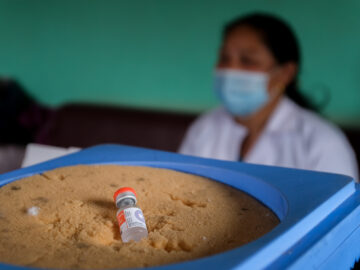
215,69 -> 269,116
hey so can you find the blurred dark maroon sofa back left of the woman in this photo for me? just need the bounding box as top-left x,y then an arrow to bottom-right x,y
35,104 -> 197,152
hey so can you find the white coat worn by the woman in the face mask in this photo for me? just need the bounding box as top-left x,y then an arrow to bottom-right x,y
179,97 -> 358,181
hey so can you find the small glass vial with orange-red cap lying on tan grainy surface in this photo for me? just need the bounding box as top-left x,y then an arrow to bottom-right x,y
114,187 -> 148,243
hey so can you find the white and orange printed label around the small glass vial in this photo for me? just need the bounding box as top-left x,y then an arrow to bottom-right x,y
117,207 -> 147,234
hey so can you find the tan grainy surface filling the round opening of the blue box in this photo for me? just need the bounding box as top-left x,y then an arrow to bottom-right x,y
0,165 -> 279,269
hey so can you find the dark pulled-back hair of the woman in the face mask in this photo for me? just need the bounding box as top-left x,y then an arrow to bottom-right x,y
223,13 -> 316,110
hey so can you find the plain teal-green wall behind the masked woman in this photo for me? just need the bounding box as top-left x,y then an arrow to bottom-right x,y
0,0 -> 360,126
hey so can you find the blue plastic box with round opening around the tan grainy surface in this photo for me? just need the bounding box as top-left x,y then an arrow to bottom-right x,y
0,145 -> 360,270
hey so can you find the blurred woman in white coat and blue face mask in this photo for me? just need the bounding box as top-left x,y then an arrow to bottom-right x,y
179,14 -> 358,181
